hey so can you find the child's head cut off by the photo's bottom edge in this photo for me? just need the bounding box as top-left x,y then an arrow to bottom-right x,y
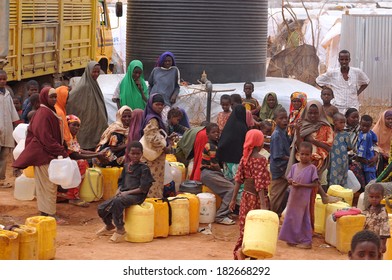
348,230 -> 382,260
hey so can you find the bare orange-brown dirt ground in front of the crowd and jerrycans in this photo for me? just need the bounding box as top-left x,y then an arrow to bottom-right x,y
0,156 -> 347,260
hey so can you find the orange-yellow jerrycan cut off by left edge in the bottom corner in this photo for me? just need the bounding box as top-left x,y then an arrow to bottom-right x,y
0,229 -> 19,260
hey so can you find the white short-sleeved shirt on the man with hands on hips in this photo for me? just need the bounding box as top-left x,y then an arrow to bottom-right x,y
316,67 -> 370,114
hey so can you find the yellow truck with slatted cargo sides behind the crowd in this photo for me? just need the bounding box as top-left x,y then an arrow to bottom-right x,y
0,0 -> 122,85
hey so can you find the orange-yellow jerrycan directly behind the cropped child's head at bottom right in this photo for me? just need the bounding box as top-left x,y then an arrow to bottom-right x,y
336,215 -> 366,253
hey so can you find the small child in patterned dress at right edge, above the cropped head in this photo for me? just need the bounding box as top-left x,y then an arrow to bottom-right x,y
362,184 -> 391,254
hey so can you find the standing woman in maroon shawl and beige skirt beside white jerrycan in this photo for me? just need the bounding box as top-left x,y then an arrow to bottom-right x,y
13,87 -> 68,223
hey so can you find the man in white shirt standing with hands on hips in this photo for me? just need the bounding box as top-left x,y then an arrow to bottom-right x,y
316,50 -> 370,114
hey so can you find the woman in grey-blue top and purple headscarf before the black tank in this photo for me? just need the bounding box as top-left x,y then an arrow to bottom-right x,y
148,52 -> 180,122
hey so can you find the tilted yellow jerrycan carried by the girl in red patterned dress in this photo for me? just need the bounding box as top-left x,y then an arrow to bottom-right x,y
242,209 -> 279,259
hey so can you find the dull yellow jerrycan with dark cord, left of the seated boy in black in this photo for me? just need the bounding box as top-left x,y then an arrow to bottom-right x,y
79,168 -> 103,202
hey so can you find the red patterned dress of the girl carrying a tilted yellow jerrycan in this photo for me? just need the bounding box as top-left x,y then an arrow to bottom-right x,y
233,157 -> 271,259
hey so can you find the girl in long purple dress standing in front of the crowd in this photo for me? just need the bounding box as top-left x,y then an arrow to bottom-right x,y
279,141 -> 319,249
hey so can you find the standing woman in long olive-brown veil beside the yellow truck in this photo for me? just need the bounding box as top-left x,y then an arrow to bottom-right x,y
67,61 -> 108,150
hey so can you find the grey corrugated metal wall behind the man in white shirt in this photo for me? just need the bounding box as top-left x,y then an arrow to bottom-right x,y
340,15 -> 392,106
